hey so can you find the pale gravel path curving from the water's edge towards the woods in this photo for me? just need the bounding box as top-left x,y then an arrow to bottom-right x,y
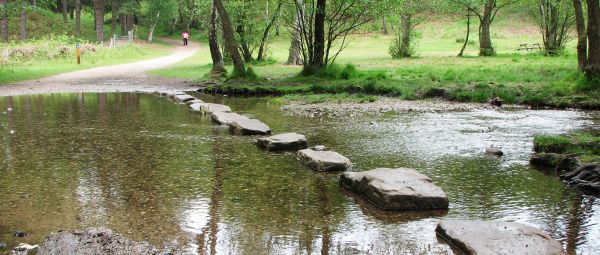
0,38 -> 200,96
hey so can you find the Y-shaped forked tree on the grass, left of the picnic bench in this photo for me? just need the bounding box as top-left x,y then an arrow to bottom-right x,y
450,0 -> 519,56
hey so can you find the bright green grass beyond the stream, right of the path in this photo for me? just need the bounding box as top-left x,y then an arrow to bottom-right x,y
153,8 -> 600,108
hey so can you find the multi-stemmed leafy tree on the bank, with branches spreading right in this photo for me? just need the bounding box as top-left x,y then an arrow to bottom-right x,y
294,0 -> 387,72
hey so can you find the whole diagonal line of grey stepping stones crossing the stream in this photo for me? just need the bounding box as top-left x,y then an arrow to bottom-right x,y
154,91 -> 565,254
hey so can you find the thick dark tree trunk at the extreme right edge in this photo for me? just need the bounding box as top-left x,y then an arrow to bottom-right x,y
585,0 -> 600,78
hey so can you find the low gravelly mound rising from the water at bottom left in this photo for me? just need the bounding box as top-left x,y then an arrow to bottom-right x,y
37,228 -> 162,255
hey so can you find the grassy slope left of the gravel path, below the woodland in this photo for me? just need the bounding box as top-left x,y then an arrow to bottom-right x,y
0,9 -> 172,84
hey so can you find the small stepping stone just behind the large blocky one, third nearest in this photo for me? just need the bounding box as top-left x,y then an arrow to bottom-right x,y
298,149 -> 352,172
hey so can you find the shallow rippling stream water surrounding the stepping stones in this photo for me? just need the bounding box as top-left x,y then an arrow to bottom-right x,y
0,94 -> 600,254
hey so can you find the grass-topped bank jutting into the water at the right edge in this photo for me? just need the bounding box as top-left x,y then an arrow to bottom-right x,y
533,132 -> 600,162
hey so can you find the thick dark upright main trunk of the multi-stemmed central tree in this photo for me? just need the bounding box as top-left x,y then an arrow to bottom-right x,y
305,0 -> 327,72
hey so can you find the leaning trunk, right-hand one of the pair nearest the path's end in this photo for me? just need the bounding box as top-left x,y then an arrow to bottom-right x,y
214,0 -> 246,76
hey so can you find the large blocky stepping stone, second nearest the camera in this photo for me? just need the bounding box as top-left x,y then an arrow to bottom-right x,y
340,168 -> 448,210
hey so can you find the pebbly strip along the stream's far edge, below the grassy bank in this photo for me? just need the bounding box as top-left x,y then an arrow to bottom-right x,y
282,98 -> 506,117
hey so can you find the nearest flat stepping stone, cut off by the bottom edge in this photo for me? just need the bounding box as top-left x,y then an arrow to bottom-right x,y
435,220 -> 565,255
